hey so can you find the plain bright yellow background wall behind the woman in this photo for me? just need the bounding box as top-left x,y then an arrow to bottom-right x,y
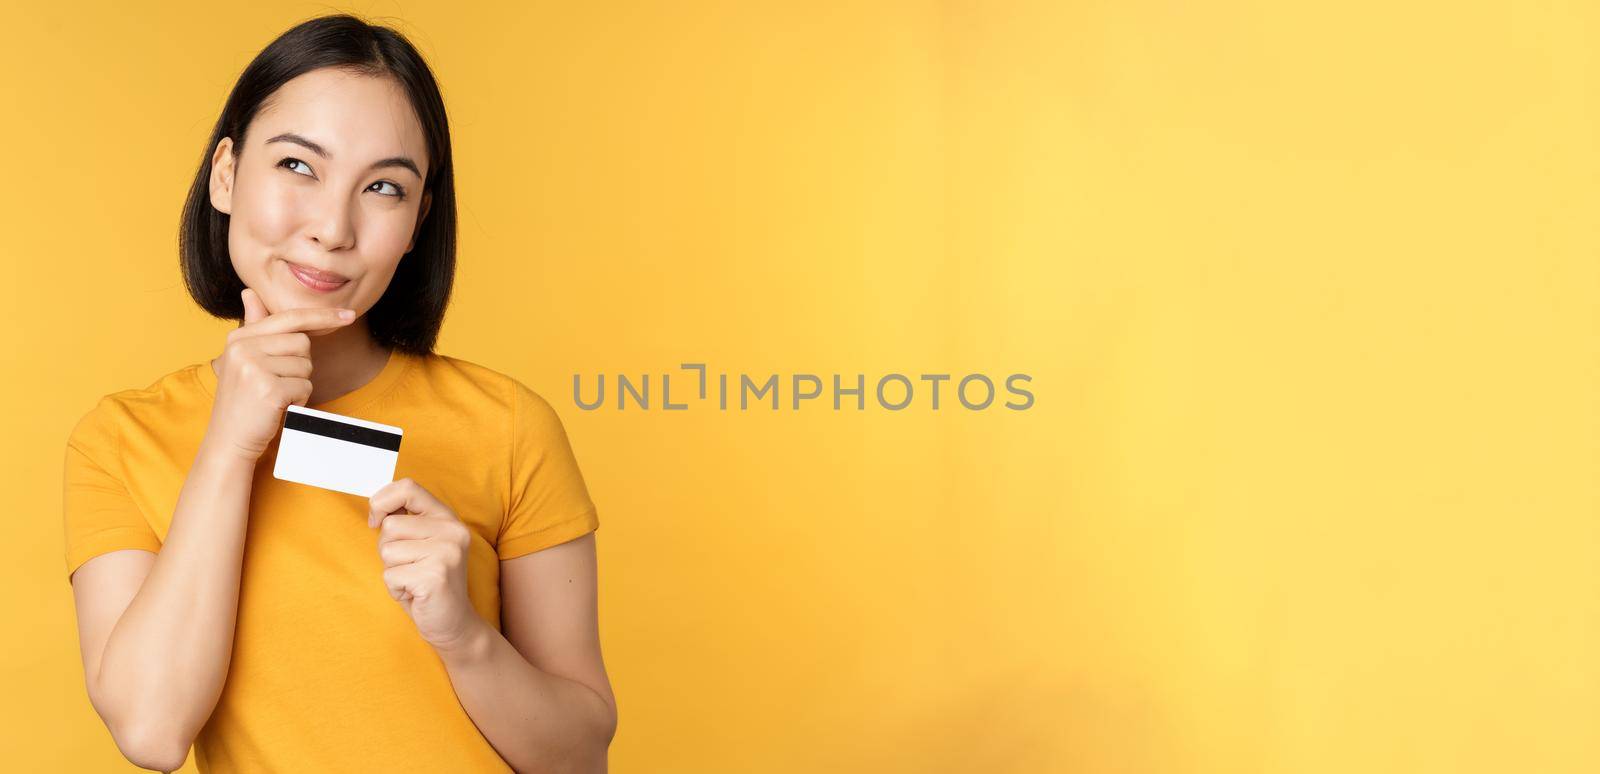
0,0 -> 1600,772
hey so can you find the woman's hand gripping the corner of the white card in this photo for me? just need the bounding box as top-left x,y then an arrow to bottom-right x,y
366,478 -> 485,651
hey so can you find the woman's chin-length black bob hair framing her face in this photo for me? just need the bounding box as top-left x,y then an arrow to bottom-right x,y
178,14 -> 456,355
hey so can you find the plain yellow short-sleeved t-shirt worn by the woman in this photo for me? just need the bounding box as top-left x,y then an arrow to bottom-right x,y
64,350 -> 600,772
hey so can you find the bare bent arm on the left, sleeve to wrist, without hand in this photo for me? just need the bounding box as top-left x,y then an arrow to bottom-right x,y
72,440 -> 256,771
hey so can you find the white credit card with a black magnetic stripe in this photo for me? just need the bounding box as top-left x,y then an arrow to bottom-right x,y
272,406 -> 402,497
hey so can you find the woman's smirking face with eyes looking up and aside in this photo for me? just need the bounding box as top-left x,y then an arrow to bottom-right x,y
211,67 -> 429,315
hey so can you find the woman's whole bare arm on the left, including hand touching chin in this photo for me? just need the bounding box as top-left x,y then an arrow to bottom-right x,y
69,299 -> 355,771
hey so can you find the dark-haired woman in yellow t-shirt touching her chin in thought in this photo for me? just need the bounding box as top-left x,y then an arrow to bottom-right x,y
64,14 -> 616,772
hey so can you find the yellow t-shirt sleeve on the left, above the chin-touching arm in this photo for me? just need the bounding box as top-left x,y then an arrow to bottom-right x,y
62,398 -> 162,581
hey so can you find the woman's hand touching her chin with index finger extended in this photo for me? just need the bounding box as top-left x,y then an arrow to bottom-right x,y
206,288 -> 355,461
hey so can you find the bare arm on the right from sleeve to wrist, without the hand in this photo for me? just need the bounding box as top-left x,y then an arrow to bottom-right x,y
435,533 -> 616,774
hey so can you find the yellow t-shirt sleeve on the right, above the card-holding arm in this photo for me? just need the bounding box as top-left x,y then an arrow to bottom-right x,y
496,382 -> 600,560
